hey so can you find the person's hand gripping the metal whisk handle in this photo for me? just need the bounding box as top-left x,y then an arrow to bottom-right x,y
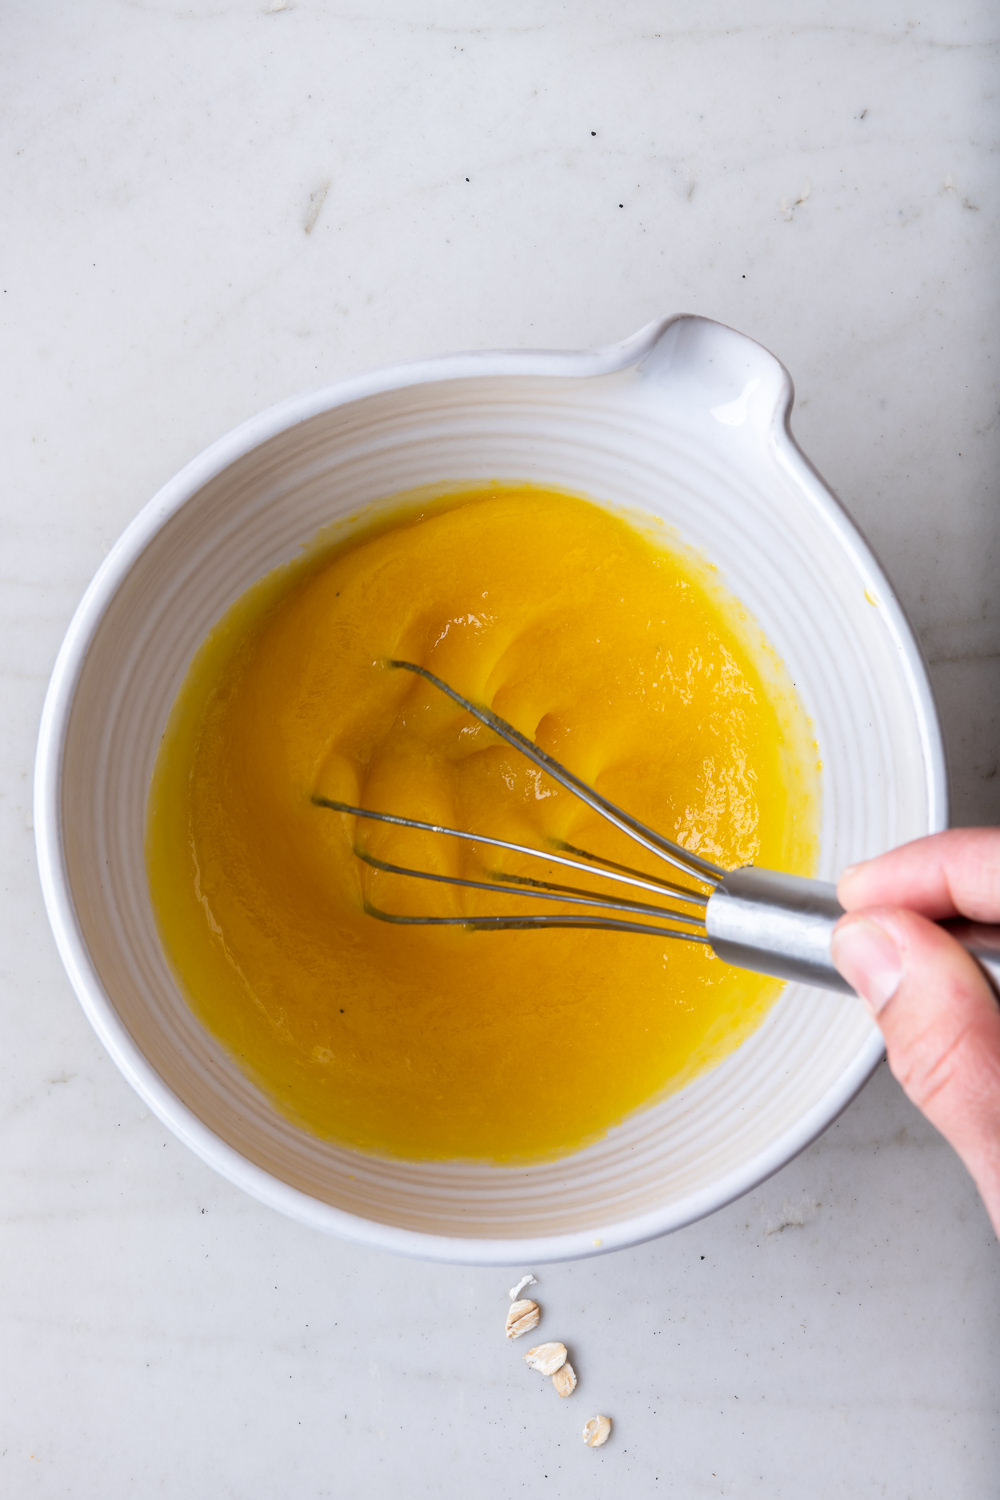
832,828 -> 1000,1235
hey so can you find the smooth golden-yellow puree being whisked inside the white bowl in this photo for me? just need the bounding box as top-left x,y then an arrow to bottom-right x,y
147,485 -> 819,1163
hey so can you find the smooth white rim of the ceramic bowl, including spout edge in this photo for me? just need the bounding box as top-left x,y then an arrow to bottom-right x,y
34,314 -> 948,1266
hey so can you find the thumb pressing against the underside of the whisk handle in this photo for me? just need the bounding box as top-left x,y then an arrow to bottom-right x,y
832,906 -> 1000,1233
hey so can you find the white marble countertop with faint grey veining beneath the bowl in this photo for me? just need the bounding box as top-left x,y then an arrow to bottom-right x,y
0,0 -> 1000,1500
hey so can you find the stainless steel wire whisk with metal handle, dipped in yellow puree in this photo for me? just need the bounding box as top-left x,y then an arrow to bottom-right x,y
313,662 -> 1000,995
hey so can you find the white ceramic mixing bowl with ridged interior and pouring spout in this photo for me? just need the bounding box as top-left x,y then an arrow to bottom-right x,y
34,318 -> 946,1265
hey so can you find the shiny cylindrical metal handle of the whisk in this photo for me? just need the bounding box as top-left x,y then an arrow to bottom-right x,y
705,866 -> 1000,996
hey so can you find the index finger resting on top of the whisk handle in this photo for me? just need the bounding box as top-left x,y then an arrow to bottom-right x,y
837,828 -> 1000,923
